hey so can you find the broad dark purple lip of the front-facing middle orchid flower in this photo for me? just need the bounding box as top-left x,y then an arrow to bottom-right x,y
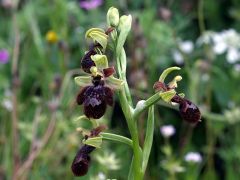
77,76 -> 113,119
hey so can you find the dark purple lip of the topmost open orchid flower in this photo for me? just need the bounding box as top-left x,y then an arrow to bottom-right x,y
81,49 -> 96,73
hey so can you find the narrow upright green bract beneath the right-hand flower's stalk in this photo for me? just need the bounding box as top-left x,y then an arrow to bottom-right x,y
142,106 -> 154,172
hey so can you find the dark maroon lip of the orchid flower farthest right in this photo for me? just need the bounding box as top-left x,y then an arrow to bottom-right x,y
172,95 -> 201,124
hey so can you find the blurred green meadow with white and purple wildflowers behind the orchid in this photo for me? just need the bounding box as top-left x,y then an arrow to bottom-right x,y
0,0 -> 240,180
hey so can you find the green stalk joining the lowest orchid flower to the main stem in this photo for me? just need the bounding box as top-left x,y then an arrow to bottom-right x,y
101,132 -> 133,148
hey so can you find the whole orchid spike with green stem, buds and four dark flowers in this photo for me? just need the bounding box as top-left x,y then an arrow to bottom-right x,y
73,7 -> 200,180
